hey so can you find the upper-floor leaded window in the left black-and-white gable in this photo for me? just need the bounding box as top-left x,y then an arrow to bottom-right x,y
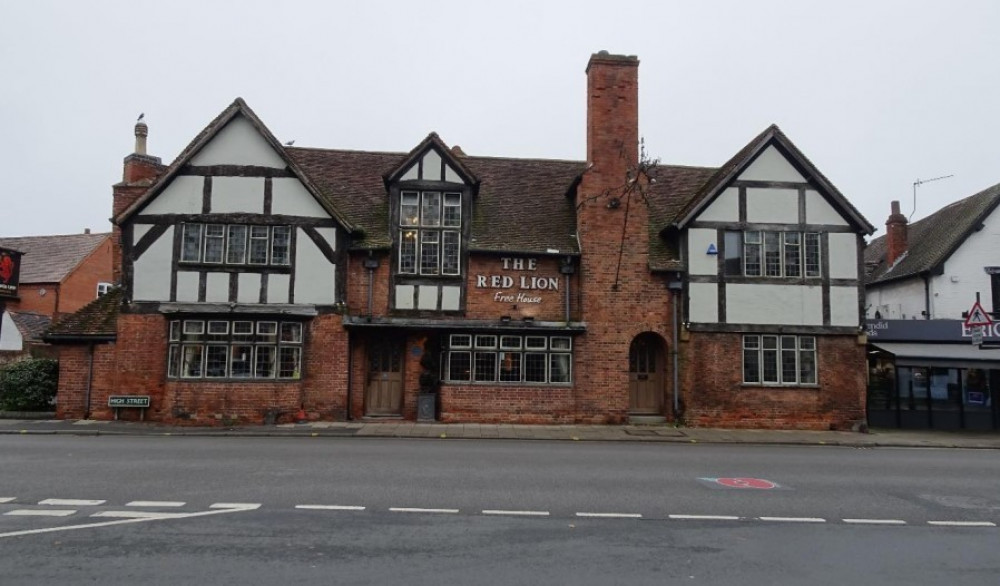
180,224 -> 292,266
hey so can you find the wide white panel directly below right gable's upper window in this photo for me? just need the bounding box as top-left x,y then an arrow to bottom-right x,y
726,283 -> 823,326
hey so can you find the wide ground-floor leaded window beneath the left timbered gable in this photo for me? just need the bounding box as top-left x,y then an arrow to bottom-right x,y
167,319 -> 303,379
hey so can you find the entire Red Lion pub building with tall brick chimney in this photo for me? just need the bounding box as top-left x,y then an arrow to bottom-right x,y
49,52 -> 873,428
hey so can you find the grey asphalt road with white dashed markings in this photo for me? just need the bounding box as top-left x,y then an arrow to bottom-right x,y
0,436 -> 1000,585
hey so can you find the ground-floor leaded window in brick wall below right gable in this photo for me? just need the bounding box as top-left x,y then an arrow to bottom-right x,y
743,335 -> 817,385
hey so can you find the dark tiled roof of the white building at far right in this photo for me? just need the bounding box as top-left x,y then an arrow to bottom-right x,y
865,184 -> 1000,285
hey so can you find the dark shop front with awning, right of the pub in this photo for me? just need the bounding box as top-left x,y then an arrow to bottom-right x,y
867,320 -> 1000,430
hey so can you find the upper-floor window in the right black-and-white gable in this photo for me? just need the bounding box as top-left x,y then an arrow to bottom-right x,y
724,230 -> 821,278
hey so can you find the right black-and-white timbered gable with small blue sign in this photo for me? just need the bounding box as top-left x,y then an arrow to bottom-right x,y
676,126 -> 873,332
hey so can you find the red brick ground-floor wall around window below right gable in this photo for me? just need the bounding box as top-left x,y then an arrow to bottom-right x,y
681,332 -> 865,430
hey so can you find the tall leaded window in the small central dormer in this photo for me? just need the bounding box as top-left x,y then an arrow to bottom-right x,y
399,191 -> 462,275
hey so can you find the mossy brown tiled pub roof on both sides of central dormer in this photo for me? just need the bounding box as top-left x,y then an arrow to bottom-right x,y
285,147 -> 585,253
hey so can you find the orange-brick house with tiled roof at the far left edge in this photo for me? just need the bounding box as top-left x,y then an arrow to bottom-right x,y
0,230 -> 112,362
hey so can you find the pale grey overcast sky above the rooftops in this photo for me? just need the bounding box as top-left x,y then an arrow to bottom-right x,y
0,0 -> 1000,236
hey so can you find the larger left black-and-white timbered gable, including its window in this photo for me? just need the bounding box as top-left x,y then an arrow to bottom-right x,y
116,99 -> 350,305
